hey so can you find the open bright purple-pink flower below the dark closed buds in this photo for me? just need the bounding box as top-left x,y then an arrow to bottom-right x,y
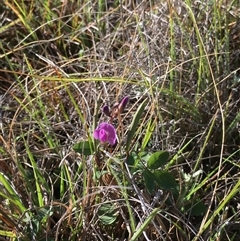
93,122 -> 117,146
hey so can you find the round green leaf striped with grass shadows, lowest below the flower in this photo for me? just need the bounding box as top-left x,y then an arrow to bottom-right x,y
98,203 -> 118,225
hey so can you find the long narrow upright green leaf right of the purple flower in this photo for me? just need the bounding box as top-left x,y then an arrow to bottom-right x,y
126,99 -> 147,152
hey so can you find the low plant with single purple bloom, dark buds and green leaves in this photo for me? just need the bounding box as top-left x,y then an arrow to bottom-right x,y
73,97 -> 182,236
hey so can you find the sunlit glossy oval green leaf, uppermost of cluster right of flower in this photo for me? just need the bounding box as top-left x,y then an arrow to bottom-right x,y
147,151 -> 169,170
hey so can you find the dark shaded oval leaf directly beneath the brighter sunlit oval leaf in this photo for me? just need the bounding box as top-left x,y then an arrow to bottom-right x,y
153,170 -> 178,190
